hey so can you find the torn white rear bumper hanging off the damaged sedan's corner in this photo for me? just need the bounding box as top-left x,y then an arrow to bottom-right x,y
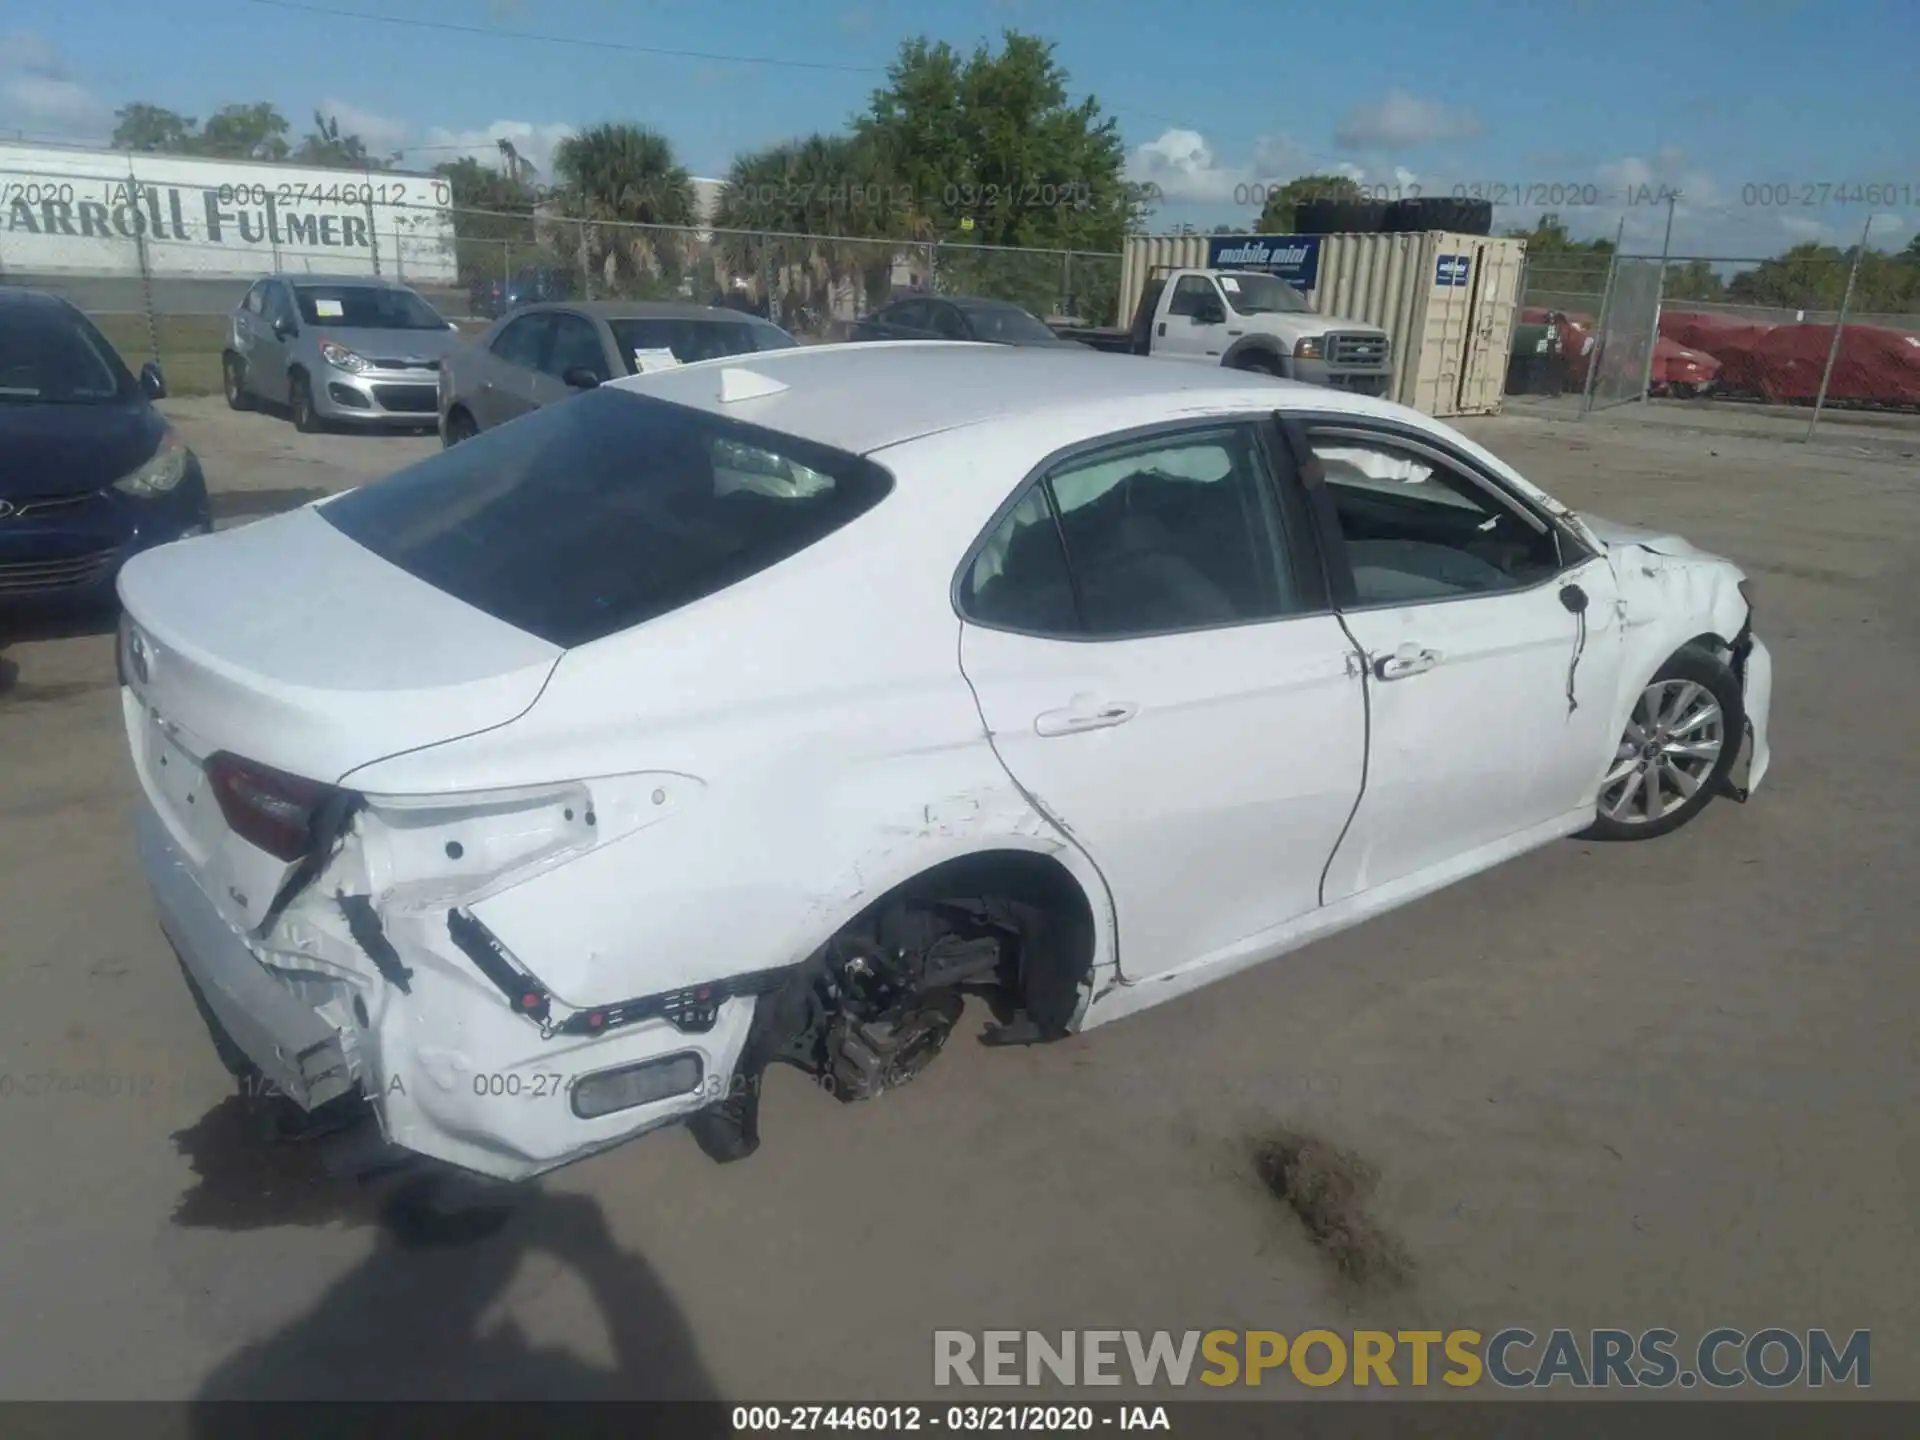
136,804 -> 756,1181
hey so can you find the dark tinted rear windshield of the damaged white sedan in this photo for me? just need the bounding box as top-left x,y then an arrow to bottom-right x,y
321,390 -> 893,647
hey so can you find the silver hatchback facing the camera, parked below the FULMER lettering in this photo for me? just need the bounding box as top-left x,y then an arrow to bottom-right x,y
221,275 -> 461,434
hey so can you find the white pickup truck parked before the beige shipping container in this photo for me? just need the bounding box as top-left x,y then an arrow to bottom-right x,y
1056,269 -> 1392,396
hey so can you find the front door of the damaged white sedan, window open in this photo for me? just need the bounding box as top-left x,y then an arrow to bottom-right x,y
1294,420 -> 1622,904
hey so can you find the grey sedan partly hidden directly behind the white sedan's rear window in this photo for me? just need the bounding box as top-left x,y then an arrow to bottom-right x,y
440,300 -> 799,445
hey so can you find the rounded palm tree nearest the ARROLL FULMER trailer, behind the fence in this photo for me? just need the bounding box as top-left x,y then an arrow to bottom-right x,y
553,123 -> 695,294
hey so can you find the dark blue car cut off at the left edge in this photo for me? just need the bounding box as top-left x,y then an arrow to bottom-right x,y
0,286 -> 213,607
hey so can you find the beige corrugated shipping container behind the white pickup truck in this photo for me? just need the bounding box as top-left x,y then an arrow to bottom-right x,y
1119,230 -> 1526,415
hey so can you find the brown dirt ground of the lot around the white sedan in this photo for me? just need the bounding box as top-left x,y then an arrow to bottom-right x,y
0,401 -> 1920,1400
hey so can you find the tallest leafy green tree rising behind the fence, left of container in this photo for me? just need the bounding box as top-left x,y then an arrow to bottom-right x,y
854,31 -> 1146,313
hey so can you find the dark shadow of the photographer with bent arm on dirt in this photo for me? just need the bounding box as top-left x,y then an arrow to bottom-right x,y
196,1175 -> 714,1413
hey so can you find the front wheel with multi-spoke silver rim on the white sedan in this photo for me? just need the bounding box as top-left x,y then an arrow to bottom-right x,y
1580,645 -> 1747,841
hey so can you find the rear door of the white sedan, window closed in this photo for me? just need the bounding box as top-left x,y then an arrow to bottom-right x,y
960,420 -> 1367,979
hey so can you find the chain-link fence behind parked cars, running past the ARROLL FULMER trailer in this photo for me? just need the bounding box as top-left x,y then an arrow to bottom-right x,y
0,156 -> 1119,394
